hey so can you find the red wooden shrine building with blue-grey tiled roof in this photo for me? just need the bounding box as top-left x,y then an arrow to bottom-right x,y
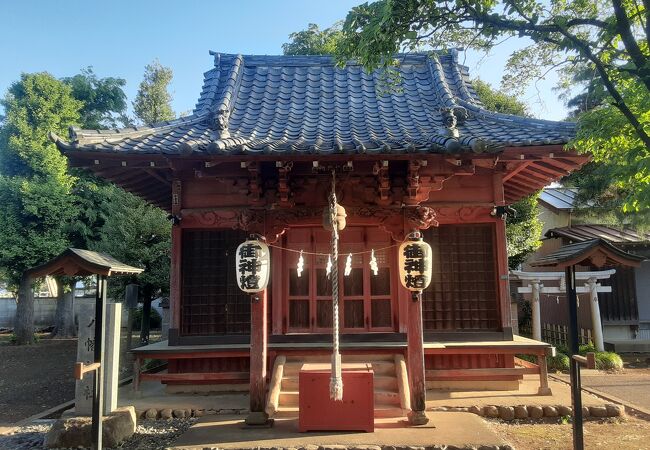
53,51 -> 588,424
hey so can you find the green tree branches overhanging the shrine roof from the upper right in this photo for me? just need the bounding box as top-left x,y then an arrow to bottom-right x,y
337,0 -> 650,212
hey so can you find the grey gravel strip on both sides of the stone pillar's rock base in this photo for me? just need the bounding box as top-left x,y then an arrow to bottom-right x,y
0,419 -> 196,450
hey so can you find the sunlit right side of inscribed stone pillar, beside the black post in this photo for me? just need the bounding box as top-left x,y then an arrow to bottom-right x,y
104,303 -> 122,415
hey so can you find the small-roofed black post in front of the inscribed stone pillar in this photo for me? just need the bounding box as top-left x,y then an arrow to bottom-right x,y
24,248 -> 144,450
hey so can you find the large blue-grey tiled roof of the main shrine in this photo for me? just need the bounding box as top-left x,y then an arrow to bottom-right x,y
54,51 -> 575,155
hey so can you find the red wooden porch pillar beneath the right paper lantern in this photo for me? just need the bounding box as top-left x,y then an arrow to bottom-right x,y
406,292 -> 429,425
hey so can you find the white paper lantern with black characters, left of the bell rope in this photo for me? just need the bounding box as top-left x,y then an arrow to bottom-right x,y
235,239 -> 271,294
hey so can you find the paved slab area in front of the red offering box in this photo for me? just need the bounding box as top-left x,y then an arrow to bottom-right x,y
171,412 -> 510,450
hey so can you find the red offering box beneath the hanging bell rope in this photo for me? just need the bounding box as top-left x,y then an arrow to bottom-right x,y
298,363 -> 375,432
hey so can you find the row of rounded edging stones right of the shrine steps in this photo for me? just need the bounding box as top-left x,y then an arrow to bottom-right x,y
428,404 -> 625,420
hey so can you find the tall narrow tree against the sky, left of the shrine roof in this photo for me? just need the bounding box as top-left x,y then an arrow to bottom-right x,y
133,60 -> 175,125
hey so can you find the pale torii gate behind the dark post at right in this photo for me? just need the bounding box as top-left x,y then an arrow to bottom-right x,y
511,269 -> 616,352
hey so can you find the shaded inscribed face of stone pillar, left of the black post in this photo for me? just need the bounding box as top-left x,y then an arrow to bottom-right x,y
70,302 -> 95,416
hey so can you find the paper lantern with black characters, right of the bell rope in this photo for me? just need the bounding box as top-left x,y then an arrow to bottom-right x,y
399,235 -> 432,291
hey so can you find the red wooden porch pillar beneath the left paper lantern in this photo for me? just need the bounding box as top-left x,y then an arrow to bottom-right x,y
246,289 -> 269,425
